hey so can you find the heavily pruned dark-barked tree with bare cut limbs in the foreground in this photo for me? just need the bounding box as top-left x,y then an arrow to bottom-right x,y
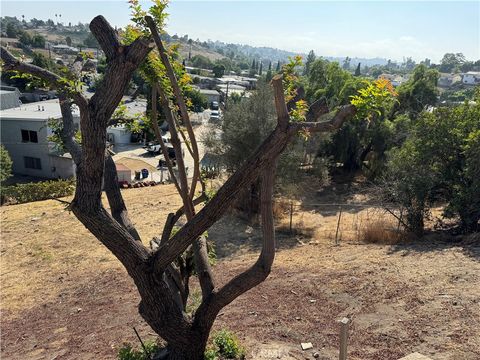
1,8 -> 356,360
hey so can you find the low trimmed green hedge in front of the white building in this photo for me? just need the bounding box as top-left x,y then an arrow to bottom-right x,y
2,179 -> 75,204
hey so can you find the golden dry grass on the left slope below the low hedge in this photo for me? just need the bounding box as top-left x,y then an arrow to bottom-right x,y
0,185 -> 181,316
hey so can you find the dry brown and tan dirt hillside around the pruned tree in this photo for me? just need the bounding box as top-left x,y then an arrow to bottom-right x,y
0,185 -> 480,360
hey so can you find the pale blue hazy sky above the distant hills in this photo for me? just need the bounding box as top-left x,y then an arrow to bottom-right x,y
1,0 -> 480,62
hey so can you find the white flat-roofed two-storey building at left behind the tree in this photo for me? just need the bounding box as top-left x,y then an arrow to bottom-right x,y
0,100 -> 80,179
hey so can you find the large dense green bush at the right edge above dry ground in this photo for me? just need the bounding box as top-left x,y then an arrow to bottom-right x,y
384,95 -> 480,235
